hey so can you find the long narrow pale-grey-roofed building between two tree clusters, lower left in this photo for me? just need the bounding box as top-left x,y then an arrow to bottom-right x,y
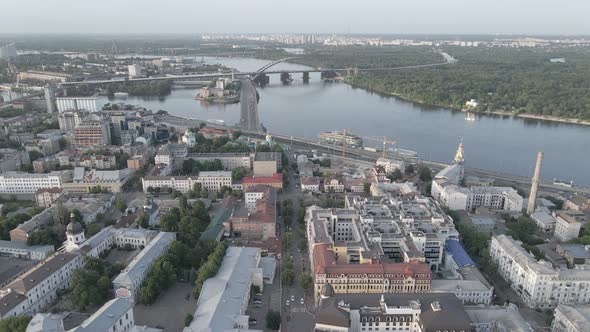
113,232 -> 176,298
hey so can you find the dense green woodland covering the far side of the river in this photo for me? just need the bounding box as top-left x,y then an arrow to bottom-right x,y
294,47 -> 590,120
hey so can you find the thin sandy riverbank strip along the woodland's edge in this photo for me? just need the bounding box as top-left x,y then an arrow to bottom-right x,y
343,80 -> 590,126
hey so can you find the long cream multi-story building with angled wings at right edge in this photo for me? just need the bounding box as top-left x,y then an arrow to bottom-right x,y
490,235 -> 590,308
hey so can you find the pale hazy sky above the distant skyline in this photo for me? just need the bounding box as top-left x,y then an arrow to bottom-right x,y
0,0 -> 590,34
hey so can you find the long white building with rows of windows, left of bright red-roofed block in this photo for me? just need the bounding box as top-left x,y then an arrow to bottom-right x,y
142,171 -> 232,193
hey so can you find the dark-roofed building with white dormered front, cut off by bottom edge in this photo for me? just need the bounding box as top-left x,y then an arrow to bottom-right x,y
314,294 -> 472,332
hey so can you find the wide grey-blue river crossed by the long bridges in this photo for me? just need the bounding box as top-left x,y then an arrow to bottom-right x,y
101,58 -> 590,185
